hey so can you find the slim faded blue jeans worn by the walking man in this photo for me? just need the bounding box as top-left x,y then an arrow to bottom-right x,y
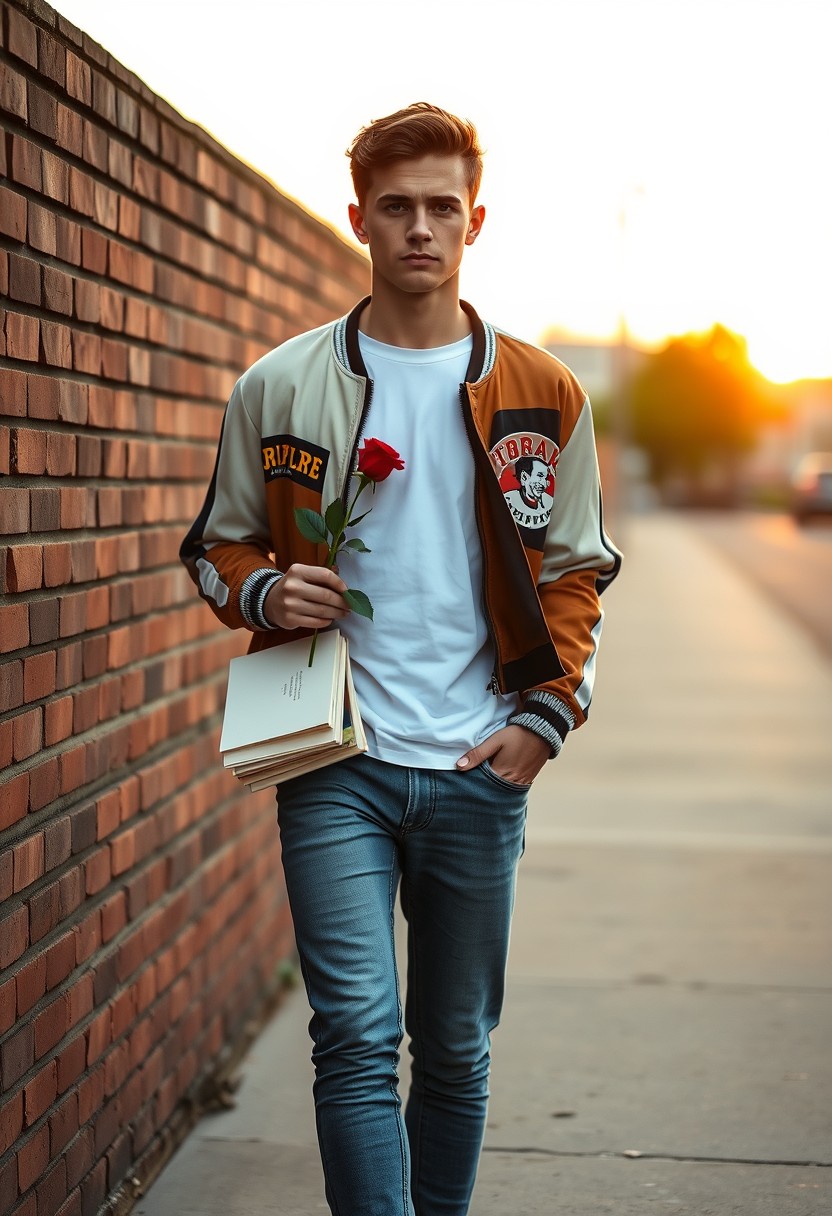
277,755 -> 528,1216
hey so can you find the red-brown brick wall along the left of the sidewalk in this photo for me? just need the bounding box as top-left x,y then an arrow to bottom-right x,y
0,0 -> 367,1216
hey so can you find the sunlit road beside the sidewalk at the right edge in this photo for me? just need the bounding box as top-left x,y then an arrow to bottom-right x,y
685,512 -> 832,658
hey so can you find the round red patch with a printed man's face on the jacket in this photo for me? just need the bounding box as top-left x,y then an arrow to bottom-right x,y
490,430 -> 560,537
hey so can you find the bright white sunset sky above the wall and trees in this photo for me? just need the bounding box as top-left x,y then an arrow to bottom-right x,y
56,0 -> 832,381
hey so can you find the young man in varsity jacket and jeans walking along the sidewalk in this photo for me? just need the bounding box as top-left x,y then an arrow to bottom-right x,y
182,103 -> 619,1216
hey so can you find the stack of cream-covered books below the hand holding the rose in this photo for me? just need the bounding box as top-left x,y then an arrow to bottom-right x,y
220,629 -> 367,790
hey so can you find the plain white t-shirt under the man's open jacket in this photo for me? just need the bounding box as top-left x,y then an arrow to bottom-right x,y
338,333 -> 518,769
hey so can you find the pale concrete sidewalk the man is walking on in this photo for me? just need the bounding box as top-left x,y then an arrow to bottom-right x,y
136,516 -> 832,1216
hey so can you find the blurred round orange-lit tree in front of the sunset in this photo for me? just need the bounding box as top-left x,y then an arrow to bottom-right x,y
630,325 -> 766,501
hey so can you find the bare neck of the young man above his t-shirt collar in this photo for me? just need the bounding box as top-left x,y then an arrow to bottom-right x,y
359,278 -> 471,350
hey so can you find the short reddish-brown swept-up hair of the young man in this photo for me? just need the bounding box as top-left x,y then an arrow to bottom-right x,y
347,101 -> 483,203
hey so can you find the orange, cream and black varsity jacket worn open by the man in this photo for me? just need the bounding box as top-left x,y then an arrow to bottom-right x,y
180,298 -> 620,755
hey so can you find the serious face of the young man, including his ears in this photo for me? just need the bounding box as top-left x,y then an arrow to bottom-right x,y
349,154 -> 485,293
